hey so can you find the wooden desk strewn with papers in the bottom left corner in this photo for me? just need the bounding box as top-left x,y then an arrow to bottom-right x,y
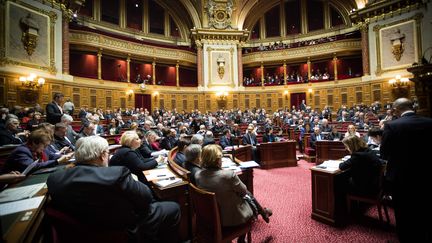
0,173 -> 50,242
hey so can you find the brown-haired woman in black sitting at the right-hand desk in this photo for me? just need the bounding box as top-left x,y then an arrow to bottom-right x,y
339,136 -> 382,195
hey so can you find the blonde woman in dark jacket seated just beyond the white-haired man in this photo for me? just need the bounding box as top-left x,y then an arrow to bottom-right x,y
109,131 -> 157,183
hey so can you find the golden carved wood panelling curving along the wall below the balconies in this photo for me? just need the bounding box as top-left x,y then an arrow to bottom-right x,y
0,73 -> 414,112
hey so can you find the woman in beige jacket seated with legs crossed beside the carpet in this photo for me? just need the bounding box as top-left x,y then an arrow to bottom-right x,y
195,144 -> 272,226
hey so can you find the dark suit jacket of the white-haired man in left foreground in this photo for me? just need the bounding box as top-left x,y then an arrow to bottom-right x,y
47,163 -> 153,228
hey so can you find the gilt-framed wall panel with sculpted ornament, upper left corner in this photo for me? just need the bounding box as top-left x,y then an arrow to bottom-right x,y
0,1 -> 57,74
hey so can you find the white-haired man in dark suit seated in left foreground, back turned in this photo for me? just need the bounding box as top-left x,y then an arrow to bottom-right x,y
47,136 -> 180,242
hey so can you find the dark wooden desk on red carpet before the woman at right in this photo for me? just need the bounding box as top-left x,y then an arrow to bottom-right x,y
311,166 -> 347,226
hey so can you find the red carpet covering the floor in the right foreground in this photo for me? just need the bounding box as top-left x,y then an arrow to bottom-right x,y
252,160 -> 398,242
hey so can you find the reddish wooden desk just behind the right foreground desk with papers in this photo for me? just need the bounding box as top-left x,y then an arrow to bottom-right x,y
315,140 -> 349,165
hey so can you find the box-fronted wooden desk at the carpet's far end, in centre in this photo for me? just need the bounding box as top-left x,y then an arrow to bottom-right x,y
257,141 -> 297,169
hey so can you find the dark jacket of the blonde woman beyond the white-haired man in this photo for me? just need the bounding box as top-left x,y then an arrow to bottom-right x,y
109,146 -> 157,183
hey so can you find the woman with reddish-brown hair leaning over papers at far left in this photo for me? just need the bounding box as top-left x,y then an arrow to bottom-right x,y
3,129 -> 72,172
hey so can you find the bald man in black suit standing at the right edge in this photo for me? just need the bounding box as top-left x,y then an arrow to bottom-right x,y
380,98 -> 432,242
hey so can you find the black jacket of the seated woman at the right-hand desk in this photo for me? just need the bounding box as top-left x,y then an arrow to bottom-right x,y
339,148 -> 381,195
